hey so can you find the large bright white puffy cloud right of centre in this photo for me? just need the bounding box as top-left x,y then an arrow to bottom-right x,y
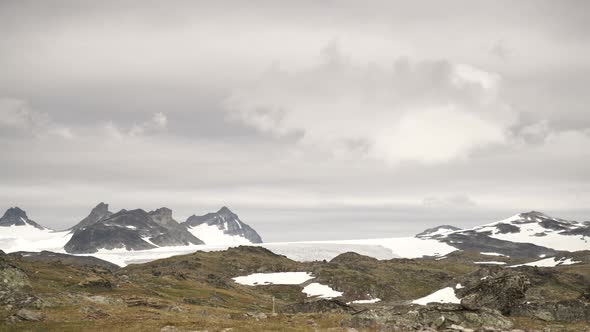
226,44 -> 519,164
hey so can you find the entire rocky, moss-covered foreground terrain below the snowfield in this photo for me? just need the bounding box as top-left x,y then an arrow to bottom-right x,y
0,247 -> 590,331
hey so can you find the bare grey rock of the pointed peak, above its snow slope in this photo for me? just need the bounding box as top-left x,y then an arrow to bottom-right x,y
182,206 -> 262,243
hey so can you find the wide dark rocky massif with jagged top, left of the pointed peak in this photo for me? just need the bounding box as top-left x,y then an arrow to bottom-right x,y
64,208 -> 203,253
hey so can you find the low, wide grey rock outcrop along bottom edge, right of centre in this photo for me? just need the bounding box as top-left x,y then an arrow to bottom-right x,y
343,303 -> 513,331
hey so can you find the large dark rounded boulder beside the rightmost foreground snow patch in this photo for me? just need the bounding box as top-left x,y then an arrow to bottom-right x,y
457,270 -> 530,314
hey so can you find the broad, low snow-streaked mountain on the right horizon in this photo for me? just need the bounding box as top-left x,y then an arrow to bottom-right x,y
416,211 -> 590,257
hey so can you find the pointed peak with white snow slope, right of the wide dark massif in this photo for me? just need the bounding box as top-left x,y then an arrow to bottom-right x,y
182,206 -> 262,244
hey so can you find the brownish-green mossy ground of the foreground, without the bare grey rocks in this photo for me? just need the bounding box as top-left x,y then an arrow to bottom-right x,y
0,247 -> 590,331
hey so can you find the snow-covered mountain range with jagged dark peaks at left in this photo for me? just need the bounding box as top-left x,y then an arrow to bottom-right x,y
0,202 -> 262,254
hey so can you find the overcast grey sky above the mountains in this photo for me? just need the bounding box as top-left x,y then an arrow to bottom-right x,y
0,0 -> 590,241
